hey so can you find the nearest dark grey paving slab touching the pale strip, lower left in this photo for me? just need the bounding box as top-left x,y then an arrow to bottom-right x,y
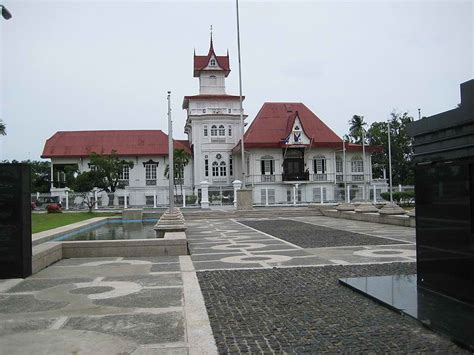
63,312 -> 185,344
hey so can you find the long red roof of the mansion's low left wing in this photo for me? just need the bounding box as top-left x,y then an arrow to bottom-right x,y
41,130 -> 190,158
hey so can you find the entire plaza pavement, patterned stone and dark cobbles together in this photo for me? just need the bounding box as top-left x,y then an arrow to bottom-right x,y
0,215 -> 462,354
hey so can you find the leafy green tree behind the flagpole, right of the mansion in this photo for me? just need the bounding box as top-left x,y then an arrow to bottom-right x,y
367,111 -> 414,185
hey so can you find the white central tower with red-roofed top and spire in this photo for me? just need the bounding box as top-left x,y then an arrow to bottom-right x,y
183,30 -> 246,192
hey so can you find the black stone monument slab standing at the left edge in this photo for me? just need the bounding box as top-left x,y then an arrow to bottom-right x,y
0,164 -> 32,279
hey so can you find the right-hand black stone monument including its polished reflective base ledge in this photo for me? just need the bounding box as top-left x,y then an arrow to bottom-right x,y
339,80 -> 474,351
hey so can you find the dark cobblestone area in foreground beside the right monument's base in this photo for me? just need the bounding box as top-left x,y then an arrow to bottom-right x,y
198,263 -> 463,354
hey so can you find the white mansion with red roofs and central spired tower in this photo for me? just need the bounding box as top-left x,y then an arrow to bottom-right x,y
42,37 -> 386,205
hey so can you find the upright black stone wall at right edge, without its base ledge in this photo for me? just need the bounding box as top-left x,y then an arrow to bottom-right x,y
410,80 -> 474,306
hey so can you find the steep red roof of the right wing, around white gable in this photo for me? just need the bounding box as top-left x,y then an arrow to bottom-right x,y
234,102 -> 379,151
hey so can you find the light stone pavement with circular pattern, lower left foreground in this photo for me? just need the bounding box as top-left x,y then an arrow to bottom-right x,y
0,256 -> 215,354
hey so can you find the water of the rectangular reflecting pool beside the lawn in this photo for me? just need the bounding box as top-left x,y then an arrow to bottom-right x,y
55,219 -> 158,241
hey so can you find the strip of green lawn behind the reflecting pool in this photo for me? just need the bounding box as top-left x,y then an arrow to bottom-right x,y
31,212 -> 117,233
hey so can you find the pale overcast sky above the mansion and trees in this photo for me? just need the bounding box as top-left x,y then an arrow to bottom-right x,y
0,0 -> 474,160
